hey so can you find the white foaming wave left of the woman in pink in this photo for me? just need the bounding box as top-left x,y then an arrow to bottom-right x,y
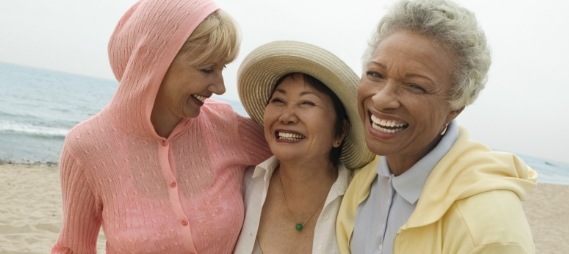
0,122 -> 69,138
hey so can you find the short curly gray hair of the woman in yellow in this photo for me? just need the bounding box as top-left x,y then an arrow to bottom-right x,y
363,0 -> 492,109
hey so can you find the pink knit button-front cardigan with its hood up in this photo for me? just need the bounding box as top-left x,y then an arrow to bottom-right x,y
52,0 -> 269,254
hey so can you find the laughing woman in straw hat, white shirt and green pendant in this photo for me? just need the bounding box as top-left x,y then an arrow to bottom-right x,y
235,41 -> 373,253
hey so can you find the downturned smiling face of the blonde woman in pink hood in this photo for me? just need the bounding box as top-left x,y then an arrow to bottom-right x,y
152,49 -> 229,136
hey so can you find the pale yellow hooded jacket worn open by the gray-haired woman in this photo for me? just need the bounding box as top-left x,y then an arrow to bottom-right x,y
336,128 -> 537,254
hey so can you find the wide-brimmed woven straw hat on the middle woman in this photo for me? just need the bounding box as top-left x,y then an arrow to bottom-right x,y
237,41 -> 374,169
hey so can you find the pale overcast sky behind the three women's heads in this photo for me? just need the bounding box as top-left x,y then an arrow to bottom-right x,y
0,0 -> 569,164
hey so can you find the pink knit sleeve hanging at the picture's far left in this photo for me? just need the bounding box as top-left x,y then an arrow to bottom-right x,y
51,146 -> 101,253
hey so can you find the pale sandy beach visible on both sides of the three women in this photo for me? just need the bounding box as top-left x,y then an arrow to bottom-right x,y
0,164 -> 569,254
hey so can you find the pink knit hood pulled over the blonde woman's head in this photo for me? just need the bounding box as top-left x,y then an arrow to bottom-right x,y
107,0 -> 219,139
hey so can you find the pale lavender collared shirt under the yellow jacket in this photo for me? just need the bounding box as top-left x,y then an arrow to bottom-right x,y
350,121 -> 458,254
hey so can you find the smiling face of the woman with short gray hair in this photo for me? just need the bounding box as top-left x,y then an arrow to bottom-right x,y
358,30 -> 460,175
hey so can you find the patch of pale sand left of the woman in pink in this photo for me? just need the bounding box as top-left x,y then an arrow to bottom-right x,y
0,164 -> 105,254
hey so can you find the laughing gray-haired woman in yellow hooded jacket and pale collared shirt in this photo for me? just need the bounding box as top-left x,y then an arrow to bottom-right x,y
337,0 -> 537,254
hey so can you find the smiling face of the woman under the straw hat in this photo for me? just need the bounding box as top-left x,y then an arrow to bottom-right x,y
263,74 -> 342,165
